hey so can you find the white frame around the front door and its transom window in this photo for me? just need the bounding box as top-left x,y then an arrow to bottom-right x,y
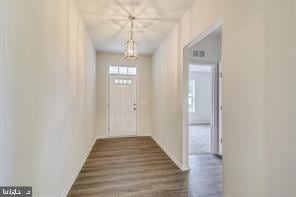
106,65 -> 141,138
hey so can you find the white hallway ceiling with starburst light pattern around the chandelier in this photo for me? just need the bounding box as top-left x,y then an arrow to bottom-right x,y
75,0 -> 193,54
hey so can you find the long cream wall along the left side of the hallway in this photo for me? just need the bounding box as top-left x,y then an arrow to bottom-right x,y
0,0 -> 96,196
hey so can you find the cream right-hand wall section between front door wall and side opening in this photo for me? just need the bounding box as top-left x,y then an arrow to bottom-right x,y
152,25 -> 186,168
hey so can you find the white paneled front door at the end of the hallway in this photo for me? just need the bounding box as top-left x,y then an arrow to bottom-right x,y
109,75 -> 137,137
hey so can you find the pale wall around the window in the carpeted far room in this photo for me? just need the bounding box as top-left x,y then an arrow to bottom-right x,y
189,70 -> 213,124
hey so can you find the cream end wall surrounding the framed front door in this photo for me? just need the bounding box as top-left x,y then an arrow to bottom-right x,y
96,53 -> 152,138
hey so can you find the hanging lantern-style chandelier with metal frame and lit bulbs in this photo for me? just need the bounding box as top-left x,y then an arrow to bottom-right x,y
124,16 -> 138,60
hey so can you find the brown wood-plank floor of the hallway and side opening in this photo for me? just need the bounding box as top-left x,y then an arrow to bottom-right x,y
68,137 -> 222,197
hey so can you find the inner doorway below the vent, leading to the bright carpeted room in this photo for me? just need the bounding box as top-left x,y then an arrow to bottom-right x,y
188,64 -> 214,155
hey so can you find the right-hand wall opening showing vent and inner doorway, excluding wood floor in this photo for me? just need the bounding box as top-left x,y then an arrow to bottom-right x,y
185,27 -> 222,155
